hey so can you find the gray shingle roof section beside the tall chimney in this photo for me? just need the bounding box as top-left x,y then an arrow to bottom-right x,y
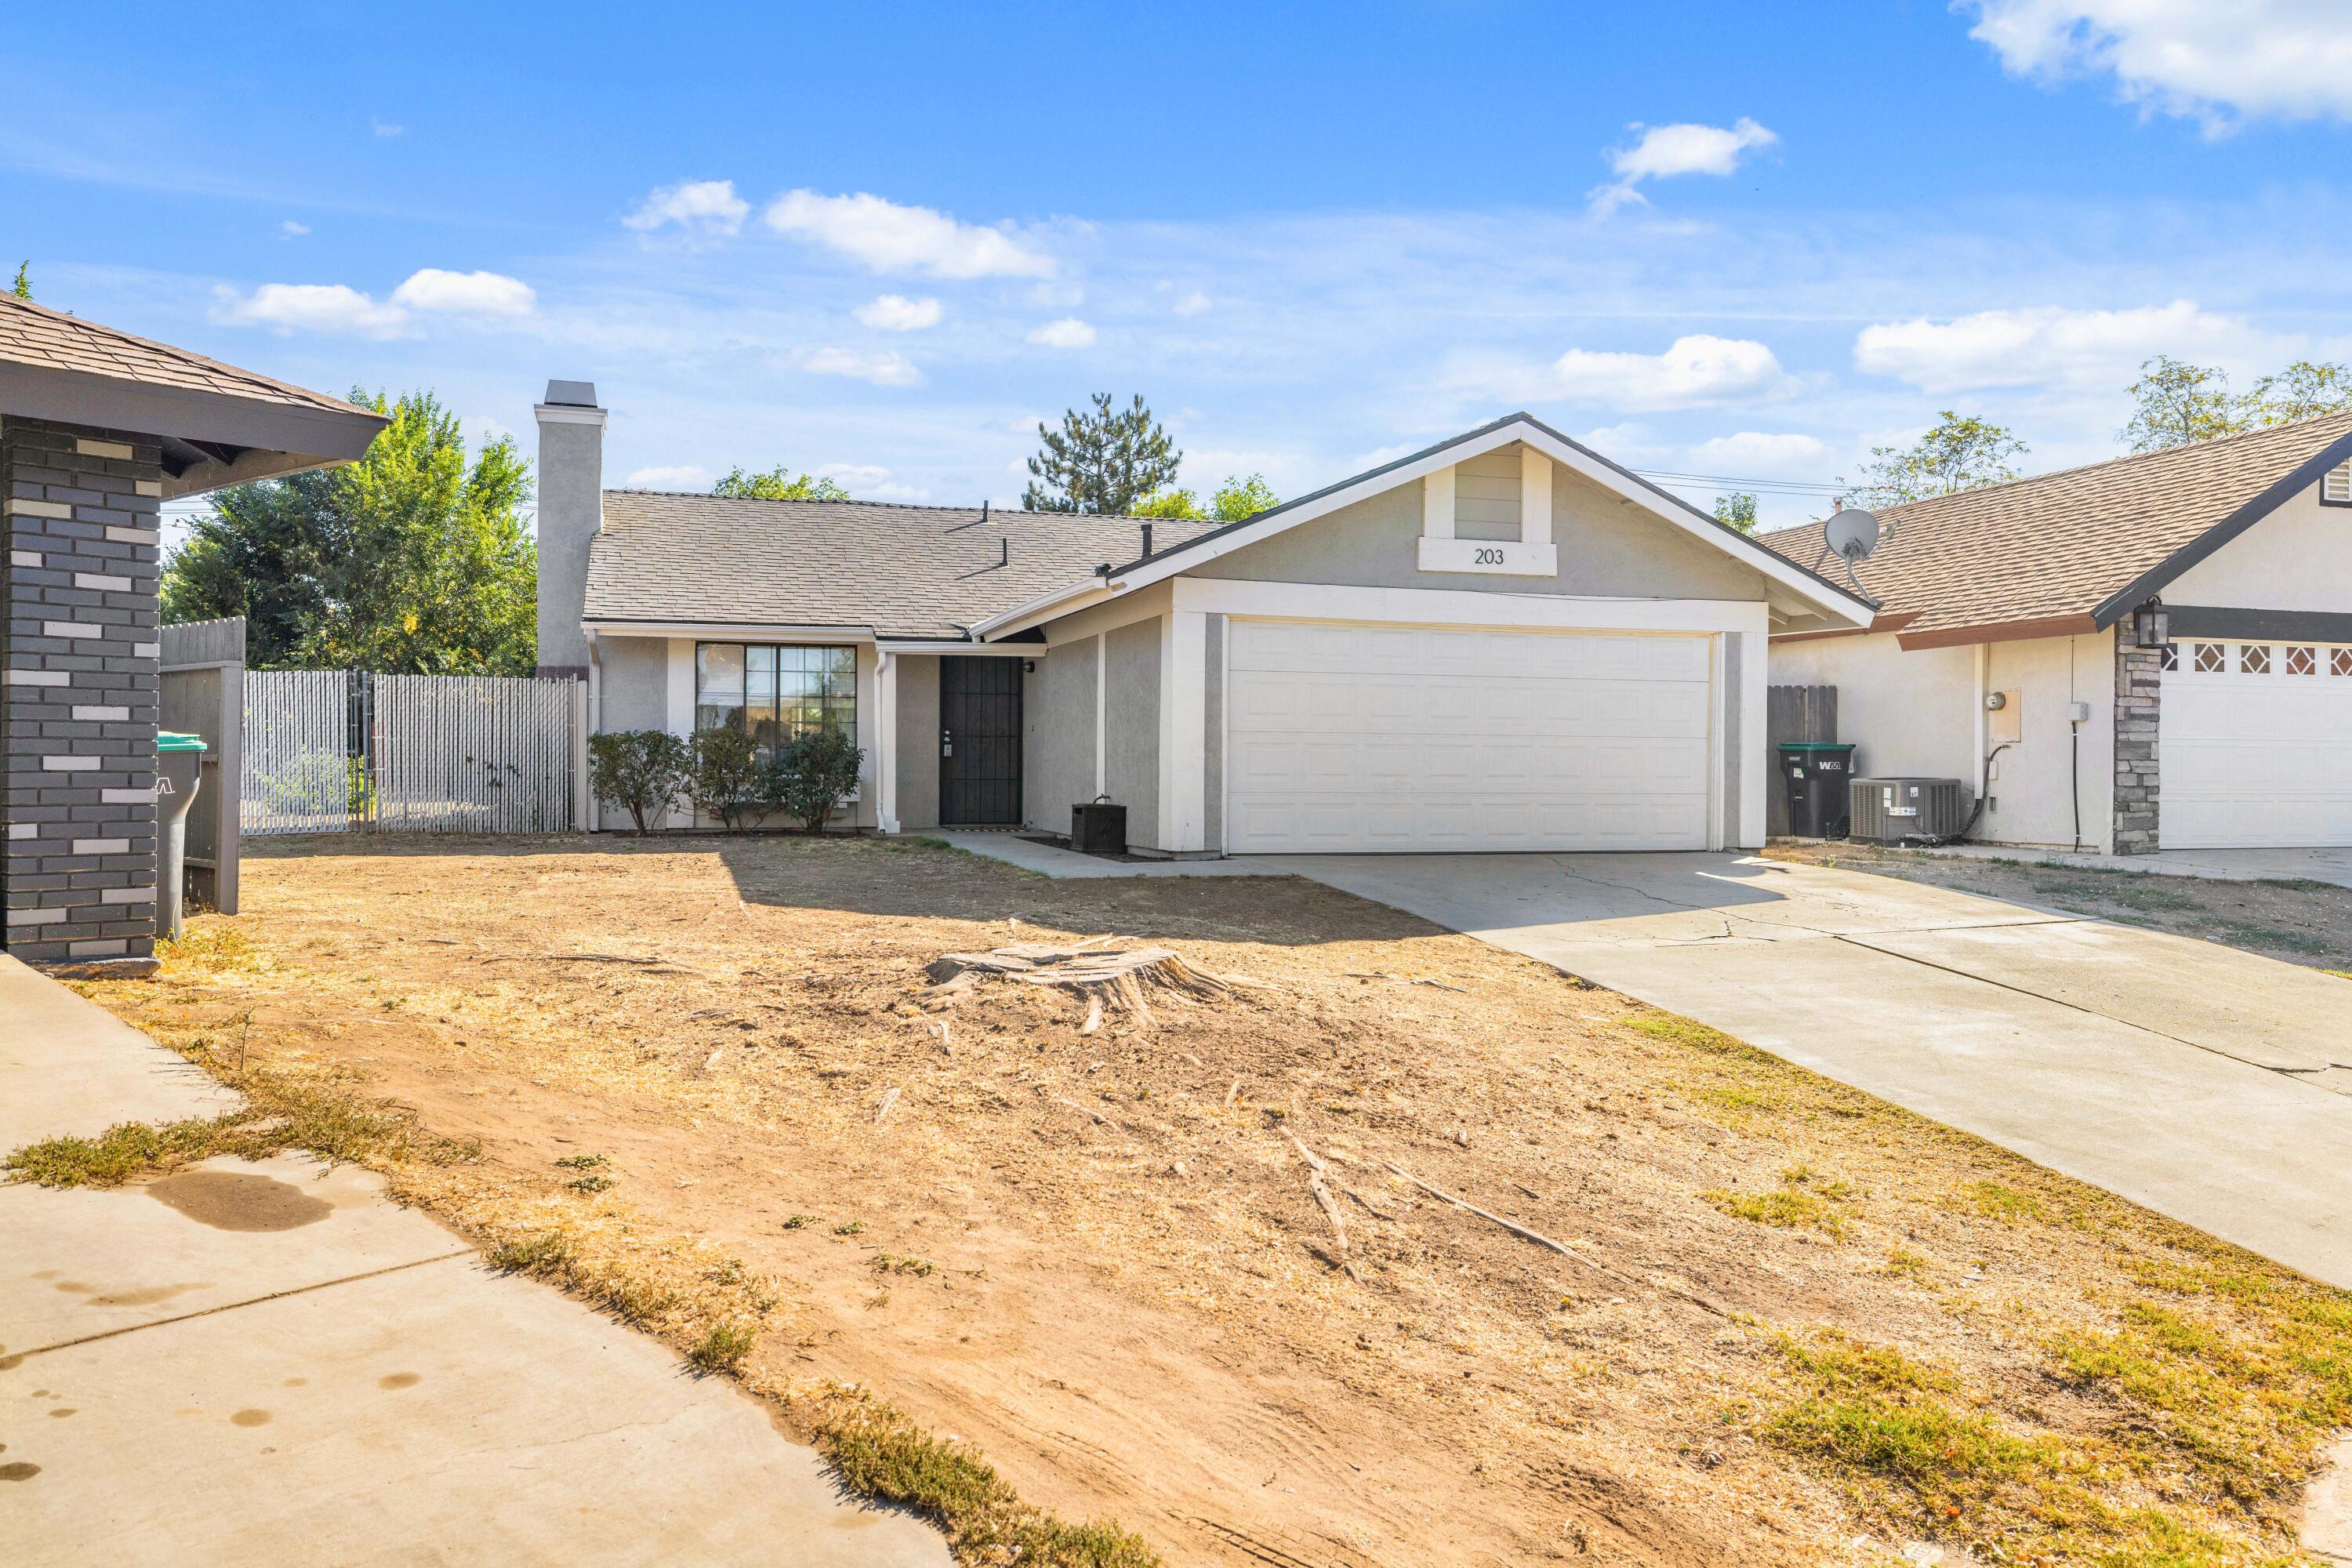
583,489 -> 1221,637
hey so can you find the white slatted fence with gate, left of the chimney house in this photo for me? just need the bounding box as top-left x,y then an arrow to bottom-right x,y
240,670 -> 586,834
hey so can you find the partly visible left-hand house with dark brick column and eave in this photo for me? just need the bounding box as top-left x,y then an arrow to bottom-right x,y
0,294 -> 383,971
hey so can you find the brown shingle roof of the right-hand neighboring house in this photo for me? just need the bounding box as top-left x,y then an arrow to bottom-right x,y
1759,414 -> 2352,637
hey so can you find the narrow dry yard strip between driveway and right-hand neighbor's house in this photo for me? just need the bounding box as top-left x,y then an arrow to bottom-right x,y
1764,841 -> 2352,973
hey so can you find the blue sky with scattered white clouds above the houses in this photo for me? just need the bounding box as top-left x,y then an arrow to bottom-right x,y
13,0 -> 2352,545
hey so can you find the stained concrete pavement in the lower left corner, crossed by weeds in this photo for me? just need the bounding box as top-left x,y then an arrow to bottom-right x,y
0,956 -> 948,1568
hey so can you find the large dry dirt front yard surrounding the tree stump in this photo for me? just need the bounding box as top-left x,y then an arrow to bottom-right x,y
68,839 -> 2352,1568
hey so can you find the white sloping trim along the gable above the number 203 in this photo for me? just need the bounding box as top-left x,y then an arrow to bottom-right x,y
971,414 -> 1875,640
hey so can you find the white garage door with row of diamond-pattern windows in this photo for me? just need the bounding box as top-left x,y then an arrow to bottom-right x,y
2157,642 -> 2352,848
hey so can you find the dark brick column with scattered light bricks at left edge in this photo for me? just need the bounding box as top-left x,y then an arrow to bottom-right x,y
0,419 -> 162,973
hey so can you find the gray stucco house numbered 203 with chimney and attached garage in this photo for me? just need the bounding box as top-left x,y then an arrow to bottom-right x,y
539,392 -> 1870,855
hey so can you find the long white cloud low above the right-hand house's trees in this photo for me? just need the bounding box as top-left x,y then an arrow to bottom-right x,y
1853,299 -> 2258,393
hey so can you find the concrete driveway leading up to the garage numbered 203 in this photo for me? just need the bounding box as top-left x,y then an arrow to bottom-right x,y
1244,853 -> 2352,1288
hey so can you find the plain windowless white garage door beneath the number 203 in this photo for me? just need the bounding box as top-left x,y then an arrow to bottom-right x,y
1225,621 -> 1712,853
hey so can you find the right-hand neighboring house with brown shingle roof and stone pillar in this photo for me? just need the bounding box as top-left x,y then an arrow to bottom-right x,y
1764,414 -> 2352,853
